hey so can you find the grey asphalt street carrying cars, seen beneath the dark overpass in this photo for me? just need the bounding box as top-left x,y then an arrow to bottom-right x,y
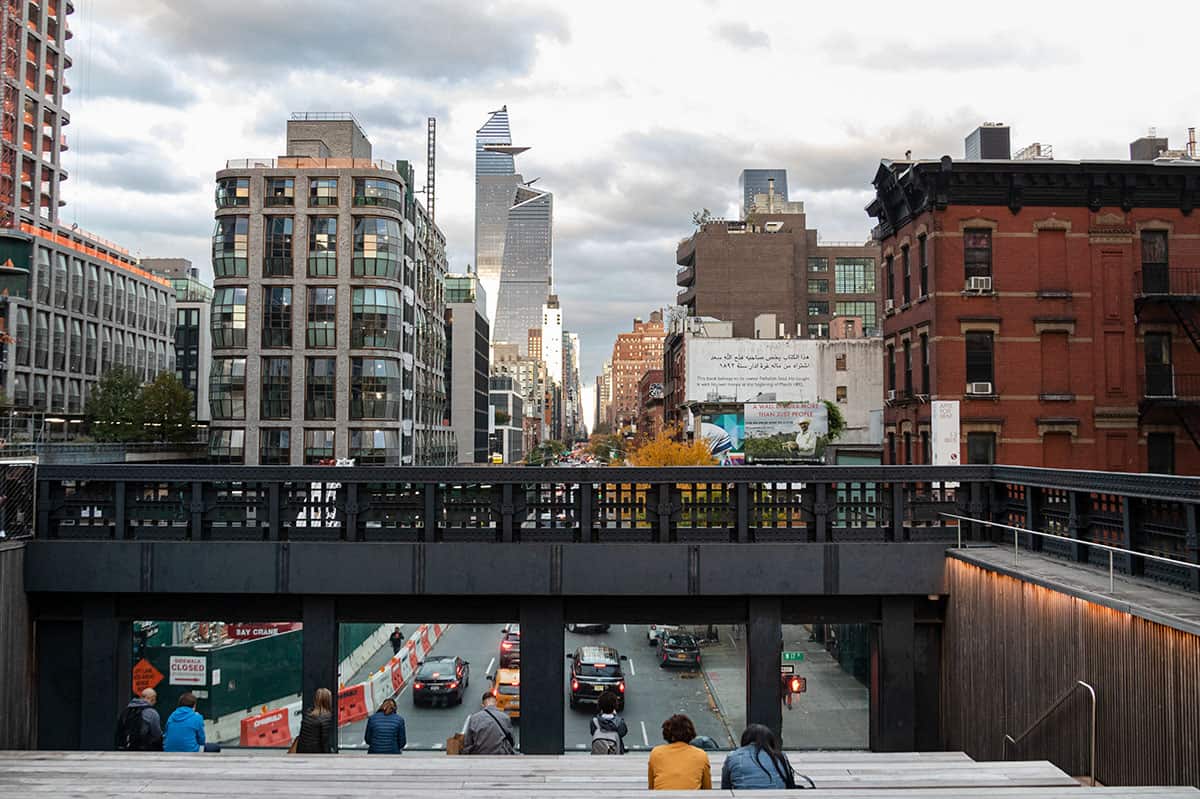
338,624 -> 730,751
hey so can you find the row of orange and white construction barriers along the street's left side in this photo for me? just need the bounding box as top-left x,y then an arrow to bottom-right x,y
239,624 -> 448,746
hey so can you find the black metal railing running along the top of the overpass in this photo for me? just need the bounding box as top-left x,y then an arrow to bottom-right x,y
25,463 -> 1200,589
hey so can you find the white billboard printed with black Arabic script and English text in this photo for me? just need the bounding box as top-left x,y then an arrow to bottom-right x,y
686,337 -> 820,402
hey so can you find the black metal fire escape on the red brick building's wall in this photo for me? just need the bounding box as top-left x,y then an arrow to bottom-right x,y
1134,263 -> 1200,449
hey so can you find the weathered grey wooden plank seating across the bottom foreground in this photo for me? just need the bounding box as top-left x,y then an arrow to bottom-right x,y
0,751 -> 1200,799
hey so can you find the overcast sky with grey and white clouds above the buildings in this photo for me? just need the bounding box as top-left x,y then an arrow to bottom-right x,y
70,0 -> 1200,379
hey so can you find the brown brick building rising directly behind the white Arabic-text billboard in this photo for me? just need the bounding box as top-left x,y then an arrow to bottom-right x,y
676,200 -> 880,338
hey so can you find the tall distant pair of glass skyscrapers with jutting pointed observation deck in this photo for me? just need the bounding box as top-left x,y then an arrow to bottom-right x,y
475,107 -> 554,355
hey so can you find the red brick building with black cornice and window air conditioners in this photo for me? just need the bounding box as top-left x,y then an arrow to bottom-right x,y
868,157 -> 1200,474
